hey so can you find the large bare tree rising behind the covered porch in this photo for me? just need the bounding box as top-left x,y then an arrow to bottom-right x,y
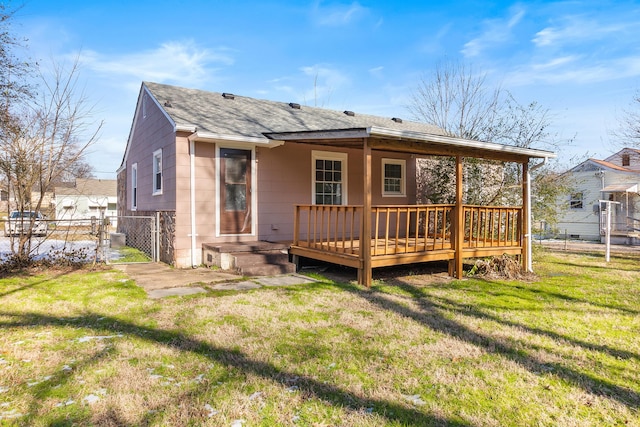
409,61 -> 563,227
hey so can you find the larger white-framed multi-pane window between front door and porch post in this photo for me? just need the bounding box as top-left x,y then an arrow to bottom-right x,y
312,151 -> 347,205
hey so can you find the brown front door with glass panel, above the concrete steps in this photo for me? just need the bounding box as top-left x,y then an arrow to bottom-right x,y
220,148 -> 252,234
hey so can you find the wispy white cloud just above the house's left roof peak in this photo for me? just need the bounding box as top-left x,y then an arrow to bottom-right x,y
80,41 -> 233,86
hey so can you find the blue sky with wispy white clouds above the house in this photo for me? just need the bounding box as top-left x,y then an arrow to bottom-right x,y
12,0 -> 640,178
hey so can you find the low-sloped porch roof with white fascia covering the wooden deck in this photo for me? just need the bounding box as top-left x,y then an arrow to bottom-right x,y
264,126 -> 556,163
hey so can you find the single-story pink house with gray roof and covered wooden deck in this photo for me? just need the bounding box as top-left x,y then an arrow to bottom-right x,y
117,82 -> 555,284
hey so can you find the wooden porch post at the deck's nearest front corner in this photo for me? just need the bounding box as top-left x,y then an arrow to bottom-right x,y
358,138 -> 373,288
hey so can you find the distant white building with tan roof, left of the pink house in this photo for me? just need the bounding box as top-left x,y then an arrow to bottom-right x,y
53,178 -> 118,225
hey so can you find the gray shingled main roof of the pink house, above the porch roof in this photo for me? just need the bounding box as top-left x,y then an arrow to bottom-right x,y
144,82 -> 444,139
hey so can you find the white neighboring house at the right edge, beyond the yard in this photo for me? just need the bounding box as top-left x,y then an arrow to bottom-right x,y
557,148 -> 640,245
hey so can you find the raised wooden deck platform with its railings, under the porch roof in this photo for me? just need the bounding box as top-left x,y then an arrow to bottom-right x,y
290,205 -> 523,278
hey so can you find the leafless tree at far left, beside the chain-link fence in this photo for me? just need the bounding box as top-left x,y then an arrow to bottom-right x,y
0,56 -> 102,256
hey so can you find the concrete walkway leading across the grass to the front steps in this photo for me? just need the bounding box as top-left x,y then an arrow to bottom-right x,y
113,263 -> 315,299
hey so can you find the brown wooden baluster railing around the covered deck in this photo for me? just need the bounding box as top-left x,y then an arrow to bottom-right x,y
293,204 -> 522,257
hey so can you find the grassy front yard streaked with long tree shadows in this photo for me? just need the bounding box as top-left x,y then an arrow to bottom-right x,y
0,246 -> 640,426
